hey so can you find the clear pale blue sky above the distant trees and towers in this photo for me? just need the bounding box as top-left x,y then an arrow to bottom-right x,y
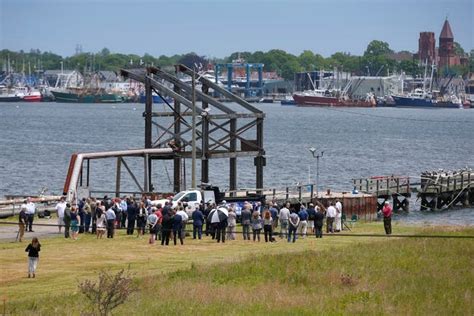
0,0 -> 474,58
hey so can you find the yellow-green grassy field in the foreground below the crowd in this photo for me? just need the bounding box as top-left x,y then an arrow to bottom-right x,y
0,223 -> 474,315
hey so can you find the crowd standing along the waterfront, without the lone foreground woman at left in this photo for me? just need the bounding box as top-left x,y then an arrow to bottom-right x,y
19,196 -> 391,245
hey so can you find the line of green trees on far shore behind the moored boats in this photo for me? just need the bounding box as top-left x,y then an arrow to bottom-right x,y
0,40 -> 474,80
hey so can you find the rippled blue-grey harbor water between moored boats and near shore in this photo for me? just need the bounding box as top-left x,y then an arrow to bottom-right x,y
0,103 -> 474,225
